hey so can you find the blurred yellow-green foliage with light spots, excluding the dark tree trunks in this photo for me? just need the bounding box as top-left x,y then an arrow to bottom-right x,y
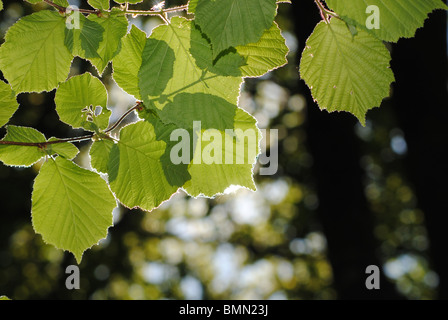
0,1 -> 438,299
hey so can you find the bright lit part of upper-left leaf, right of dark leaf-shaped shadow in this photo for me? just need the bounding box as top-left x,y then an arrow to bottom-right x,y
87,11 -> 128,74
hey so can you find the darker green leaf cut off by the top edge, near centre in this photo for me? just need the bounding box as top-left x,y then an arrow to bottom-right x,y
195,0 -> 277,57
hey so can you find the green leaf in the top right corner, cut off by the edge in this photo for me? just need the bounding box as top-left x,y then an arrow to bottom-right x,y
326,0 -> 448,42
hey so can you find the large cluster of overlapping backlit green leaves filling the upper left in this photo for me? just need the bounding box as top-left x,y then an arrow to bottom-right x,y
0,0 -> 288,262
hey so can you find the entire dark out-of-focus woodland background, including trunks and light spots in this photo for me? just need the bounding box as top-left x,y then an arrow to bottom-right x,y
0,0 -> 448,300
